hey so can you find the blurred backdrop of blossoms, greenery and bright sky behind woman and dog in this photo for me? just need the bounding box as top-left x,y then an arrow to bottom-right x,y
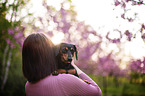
0,0 -> 145,96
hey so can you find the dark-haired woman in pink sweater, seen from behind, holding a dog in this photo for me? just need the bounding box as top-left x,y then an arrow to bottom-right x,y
22,33 -> 102,96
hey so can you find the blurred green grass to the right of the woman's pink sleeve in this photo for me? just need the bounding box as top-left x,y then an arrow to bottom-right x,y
89,75 -> 145,96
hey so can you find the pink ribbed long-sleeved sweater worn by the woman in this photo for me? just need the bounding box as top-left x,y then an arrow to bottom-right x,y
25,73 -> 102,96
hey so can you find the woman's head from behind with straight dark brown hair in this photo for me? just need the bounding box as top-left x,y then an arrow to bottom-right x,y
22,33 -> 57,82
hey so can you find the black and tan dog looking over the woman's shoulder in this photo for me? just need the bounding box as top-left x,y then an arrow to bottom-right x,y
55,43 -> 79,77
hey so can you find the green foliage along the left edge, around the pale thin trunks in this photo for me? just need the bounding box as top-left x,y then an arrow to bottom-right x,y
0,0 -> 29,96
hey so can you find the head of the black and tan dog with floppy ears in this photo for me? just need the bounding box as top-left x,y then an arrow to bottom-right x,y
55,43 -> 78,63
